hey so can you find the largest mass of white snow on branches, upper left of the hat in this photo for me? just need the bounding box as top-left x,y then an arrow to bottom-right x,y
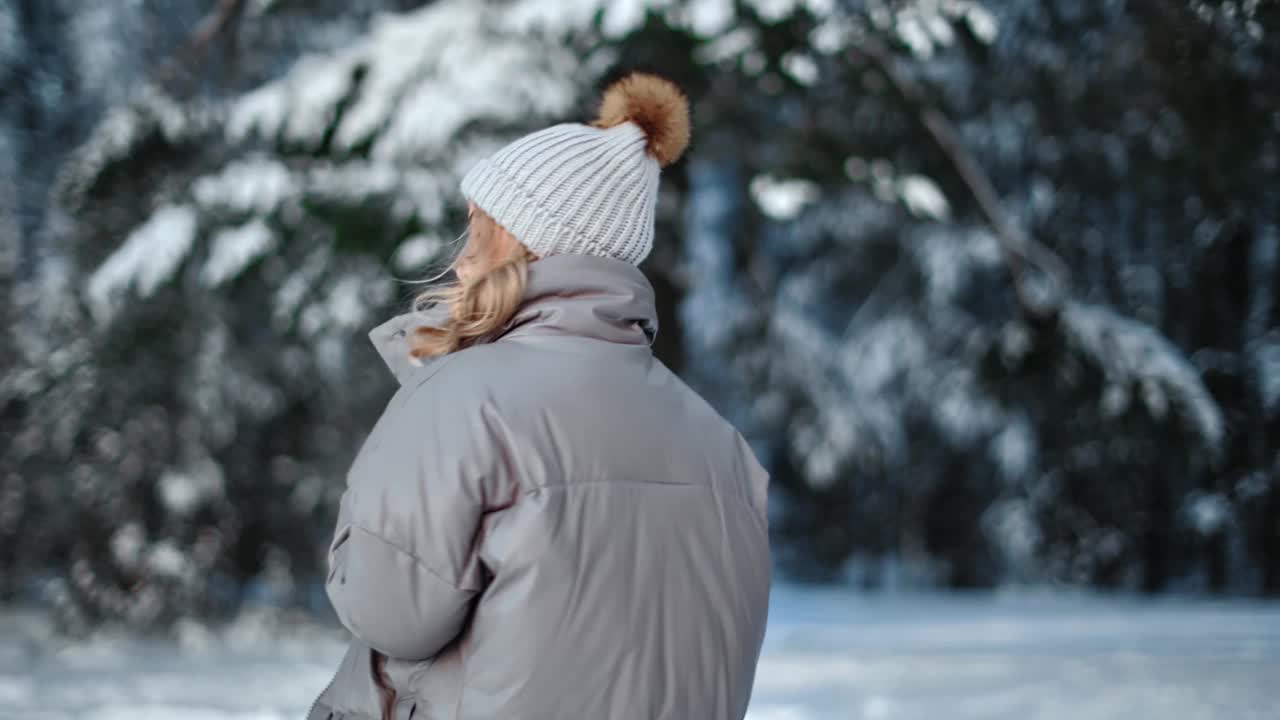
228,0 -> 577,161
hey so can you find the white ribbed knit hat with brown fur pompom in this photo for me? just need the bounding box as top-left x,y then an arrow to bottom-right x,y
462,73 -> 689,265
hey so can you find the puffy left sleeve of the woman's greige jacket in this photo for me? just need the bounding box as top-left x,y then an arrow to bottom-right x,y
325,381 -> 489,661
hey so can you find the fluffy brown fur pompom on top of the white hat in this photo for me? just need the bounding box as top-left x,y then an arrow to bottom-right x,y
593,73 -> 689,167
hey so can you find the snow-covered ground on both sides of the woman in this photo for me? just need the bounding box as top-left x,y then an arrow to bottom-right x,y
0,588 -> 1280,720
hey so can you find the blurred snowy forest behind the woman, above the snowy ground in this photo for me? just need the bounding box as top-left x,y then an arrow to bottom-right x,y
0,0 -> 1280,628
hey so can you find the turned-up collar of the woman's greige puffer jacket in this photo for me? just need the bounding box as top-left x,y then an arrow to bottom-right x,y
369,255 -> 658,384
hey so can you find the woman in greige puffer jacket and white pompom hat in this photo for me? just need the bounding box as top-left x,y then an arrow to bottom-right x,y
308,74 -> 769,720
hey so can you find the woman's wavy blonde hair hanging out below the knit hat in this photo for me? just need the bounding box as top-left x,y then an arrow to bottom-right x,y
410,208 -> 538,360
